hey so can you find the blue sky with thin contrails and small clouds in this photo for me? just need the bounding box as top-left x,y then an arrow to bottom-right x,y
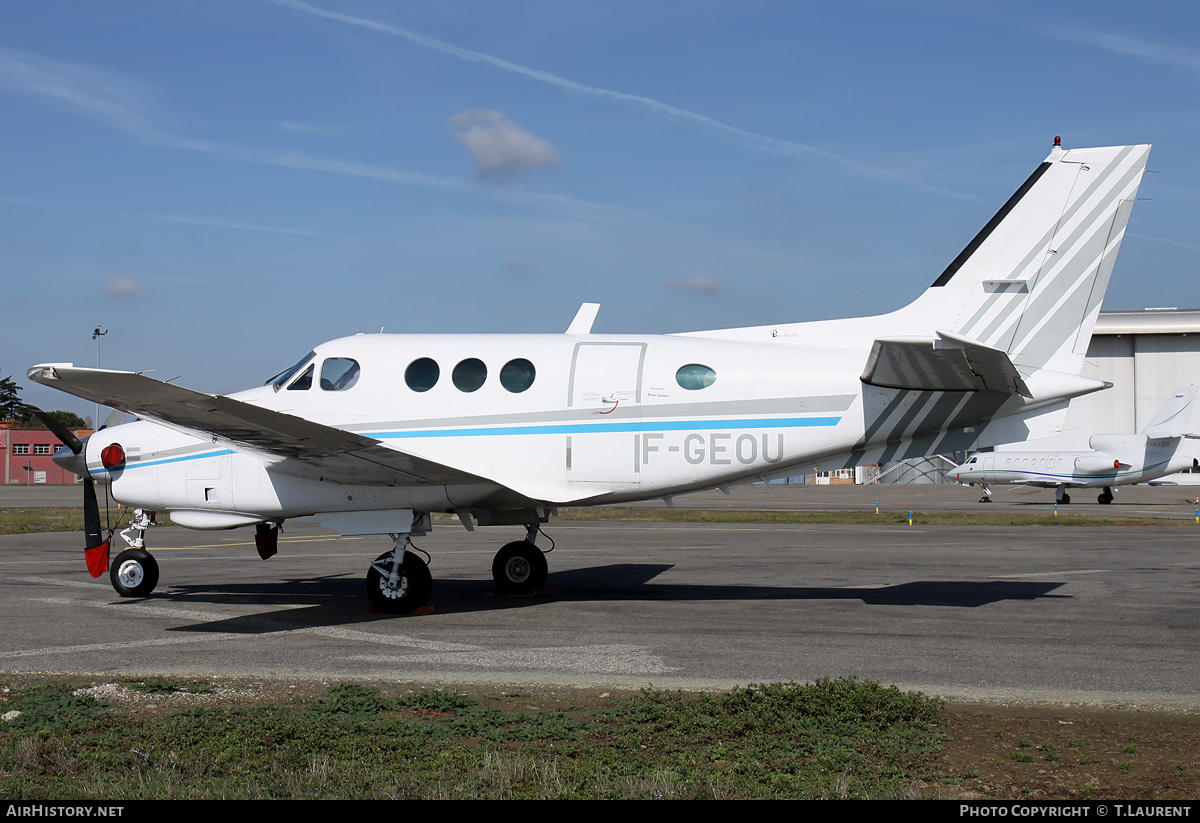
0,0 -> 1200,413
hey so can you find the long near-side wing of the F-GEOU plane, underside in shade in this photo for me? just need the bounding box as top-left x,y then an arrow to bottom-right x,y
29,364 -> 590,501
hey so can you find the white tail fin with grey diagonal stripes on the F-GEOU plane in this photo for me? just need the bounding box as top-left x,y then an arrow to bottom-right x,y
902,145 -> 1150,374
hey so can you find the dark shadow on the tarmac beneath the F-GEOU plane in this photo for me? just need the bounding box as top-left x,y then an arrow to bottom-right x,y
155,571 -> 1069,633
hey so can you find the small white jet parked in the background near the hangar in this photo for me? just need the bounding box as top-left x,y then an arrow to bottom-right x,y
946,386 -> 1200,504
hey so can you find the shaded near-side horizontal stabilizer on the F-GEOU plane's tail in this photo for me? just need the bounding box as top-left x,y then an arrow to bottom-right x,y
862,331 -> 1032,397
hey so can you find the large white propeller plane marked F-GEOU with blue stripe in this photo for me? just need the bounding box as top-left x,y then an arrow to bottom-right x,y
29,138 -> 1150,612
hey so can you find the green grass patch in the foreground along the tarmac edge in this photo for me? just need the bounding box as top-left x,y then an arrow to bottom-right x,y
0,679 -> 943,800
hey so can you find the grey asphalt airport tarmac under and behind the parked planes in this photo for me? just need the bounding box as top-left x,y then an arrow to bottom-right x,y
0,486 -> 1200,709
